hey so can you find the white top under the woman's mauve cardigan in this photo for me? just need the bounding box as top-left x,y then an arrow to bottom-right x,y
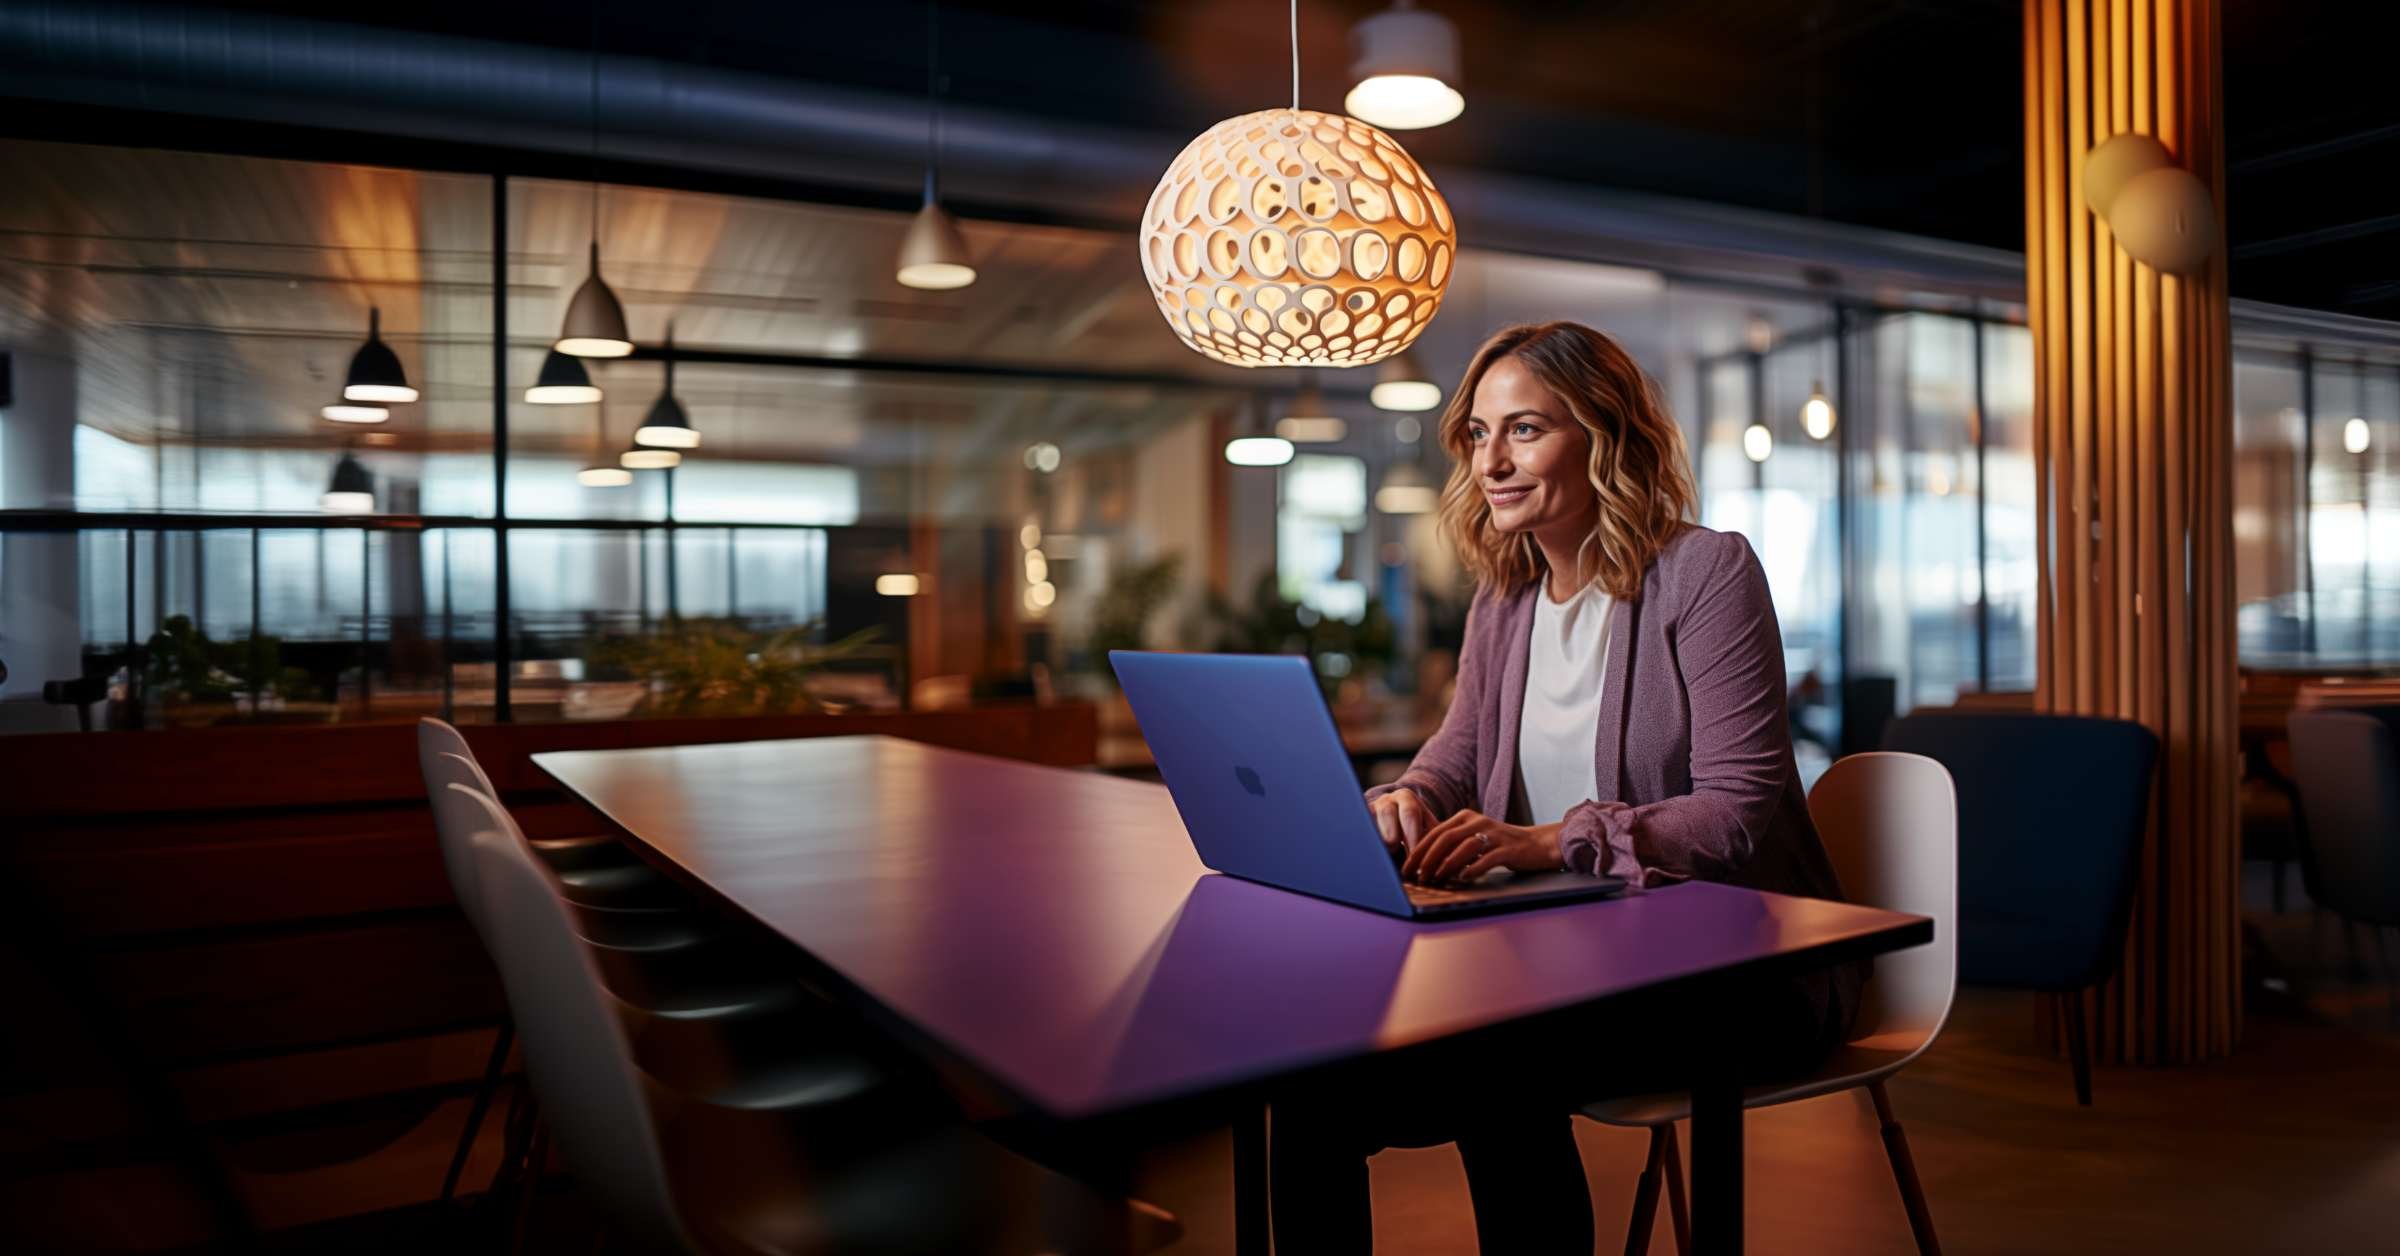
1517,584 -> 1615,824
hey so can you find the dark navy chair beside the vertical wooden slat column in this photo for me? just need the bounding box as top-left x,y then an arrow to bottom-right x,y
1884,711 -> 2158,1107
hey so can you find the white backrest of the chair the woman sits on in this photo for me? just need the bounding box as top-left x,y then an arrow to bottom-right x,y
1807,752 -> 1958,1049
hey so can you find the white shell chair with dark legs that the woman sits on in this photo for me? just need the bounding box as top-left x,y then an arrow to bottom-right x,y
1584,752 -> 1958,1254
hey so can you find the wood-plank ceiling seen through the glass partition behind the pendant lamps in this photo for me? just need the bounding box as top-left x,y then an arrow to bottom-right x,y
0,139 -> 1822,477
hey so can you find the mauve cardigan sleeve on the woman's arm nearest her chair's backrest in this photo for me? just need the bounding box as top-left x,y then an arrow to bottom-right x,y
1560,533 -> 1790,886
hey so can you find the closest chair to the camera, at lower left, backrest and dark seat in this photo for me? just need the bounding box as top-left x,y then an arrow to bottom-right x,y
473,829 -> 1181,1254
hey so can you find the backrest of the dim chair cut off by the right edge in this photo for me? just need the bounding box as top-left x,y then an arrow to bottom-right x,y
2290,708 -> 2400,925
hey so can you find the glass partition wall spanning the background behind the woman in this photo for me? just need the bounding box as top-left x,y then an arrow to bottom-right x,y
0,142 -> 2400,739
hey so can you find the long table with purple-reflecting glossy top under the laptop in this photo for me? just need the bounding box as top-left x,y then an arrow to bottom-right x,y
533,737 -> 1932,1251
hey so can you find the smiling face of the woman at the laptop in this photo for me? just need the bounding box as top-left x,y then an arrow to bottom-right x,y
1466,358 -> 1598,538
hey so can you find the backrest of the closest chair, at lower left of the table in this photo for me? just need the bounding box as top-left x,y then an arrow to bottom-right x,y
470,826 -> 694,1251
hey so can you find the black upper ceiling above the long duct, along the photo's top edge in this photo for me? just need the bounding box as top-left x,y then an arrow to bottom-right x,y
177,0 -> 2400,317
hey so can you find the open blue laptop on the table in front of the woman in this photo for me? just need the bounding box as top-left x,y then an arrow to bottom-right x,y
1109,651 -> 1625,920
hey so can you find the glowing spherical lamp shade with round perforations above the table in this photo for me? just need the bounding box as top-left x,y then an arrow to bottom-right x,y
1142,108 -> 1459,367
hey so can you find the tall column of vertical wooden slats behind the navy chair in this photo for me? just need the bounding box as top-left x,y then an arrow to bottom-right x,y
2023,0 -> 2242,1061
